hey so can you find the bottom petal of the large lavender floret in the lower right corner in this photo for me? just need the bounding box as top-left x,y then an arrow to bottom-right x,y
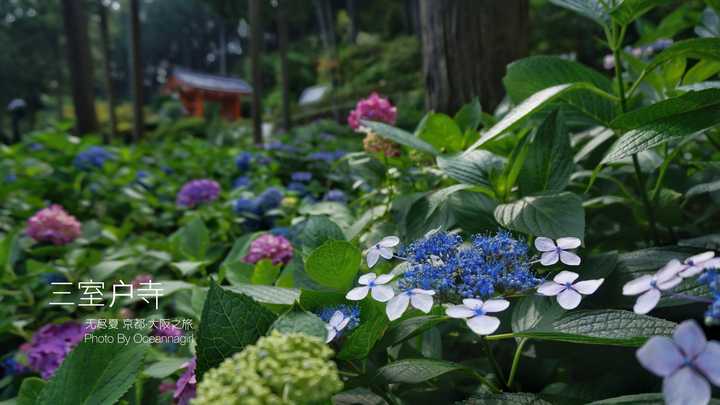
663,367 -> 711,405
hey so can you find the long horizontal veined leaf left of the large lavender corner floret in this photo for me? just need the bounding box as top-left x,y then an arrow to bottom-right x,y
514,309 -> 676,347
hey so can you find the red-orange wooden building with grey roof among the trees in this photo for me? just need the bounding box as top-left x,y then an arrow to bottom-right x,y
165,68 -> 252,121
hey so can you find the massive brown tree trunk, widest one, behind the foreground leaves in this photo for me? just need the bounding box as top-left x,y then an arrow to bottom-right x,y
420,0 -> 529,114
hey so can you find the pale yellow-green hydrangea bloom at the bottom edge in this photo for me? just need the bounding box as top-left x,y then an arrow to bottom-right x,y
193,331 -> 343,405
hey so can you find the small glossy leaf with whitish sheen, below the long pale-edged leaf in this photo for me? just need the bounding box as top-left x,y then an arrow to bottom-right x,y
437,150 -> 507,189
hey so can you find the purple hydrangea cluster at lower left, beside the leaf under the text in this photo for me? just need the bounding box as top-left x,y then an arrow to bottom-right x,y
20,322 -> 89,379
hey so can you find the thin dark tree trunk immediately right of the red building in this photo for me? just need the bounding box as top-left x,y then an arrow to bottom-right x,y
249,0 -> 263,145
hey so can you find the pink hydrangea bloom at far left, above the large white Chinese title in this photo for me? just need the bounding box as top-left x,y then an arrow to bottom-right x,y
26,204 -> 81,245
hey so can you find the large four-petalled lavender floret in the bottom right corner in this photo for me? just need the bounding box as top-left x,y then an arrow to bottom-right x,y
636,320 -> 720,405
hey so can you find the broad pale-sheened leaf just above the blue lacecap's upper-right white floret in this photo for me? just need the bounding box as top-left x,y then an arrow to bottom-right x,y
495,192 -> 585,239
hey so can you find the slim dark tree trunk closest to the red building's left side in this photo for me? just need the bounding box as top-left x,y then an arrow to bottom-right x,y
130,0 -> 145,141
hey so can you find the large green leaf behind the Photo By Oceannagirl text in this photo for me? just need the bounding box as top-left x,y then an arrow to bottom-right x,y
37,327 -> 149,405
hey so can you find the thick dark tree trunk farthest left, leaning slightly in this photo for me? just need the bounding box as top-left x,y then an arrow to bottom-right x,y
62,0 -> 98,135
